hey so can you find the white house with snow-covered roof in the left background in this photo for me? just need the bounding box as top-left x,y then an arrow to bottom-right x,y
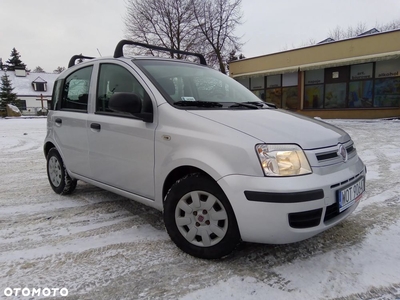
0,69 -> 59,115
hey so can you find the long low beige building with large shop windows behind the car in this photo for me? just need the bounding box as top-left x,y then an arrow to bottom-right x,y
229,30 -> 400,118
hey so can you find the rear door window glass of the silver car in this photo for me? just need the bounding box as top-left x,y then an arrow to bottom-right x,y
61,66 -> 93,112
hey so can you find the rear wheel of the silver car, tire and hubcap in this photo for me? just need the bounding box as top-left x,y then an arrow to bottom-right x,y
47,148 -> 77,195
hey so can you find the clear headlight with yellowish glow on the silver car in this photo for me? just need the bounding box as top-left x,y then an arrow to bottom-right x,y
256,144 -> 312,176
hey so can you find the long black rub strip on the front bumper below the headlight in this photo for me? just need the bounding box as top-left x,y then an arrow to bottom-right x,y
244,190 -> 324,203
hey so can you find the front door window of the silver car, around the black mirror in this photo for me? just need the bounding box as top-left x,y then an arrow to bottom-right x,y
96,64 -> 153,113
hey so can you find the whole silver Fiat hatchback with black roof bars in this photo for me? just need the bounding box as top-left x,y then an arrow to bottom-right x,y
44,40 -> 366,258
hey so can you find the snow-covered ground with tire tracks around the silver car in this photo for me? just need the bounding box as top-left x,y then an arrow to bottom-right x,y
0,119 -> 400,300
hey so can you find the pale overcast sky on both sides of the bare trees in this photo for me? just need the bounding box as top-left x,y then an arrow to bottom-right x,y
0,0 -> 400,72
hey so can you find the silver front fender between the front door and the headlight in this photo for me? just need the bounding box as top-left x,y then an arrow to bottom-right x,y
155,104 -> 263,205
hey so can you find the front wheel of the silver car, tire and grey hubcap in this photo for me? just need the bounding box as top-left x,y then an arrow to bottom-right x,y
164,174 -> 240,259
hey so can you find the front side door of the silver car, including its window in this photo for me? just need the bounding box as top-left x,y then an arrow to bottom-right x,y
88,62 -> 156,199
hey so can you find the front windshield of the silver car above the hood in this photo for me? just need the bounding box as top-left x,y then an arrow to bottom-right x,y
134,59 -> 263,108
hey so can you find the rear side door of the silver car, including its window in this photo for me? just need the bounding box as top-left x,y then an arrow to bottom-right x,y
50,65 -> 93,176
